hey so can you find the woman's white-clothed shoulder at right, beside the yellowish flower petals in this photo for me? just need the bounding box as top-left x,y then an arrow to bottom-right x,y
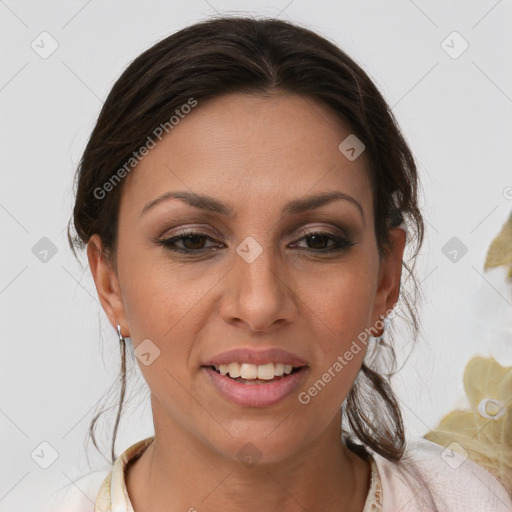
374,438 -> 512,512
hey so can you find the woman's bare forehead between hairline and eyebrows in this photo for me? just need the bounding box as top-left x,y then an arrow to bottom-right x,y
121,93 -> 371,219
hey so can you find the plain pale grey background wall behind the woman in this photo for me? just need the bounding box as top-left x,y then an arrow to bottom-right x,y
0,0 -> 512,512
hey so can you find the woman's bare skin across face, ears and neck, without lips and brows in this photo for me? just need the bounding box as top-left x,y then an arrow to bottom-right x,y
87,92 -> 405,512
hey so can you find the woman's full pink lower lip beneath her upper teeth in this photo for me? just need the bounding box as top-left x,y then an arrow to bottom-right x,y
203,366 -> 307,407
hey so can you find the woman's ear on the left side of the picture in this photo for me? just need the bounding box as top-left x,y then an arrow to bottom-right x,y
87,234 -> 129,336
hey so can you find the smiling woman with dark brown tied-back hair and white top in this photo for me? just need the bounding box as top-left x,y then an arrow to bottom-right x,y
56,18 -> 512,512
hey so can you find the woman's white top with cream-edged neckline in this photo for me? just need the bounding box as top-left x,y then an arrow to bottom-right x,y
48,437 -> 512,512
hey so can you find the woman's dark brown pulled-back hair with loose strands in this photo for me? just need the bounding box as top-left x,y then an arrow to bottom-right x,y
68,17 -> 436,508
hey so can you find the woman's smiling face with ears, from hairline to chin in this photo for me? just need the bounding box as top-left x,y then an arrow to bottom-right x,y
88,93 -> 405,461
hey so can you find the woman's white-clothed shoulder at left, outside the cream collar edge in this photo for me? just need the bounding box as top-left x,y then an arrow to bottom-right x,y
45,466 -> 112,512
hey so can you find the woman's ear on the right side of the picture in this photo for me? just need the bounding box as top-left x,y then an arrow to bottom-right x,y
372,227 -> 406,337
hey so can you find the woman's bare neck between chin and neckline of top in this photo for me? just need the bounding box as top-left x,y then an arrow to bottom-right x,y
126,406 -> 370,512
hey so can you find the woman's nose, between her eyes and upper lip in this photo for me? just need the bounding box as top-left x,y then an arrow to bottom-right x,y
220,242 -> 297,333
